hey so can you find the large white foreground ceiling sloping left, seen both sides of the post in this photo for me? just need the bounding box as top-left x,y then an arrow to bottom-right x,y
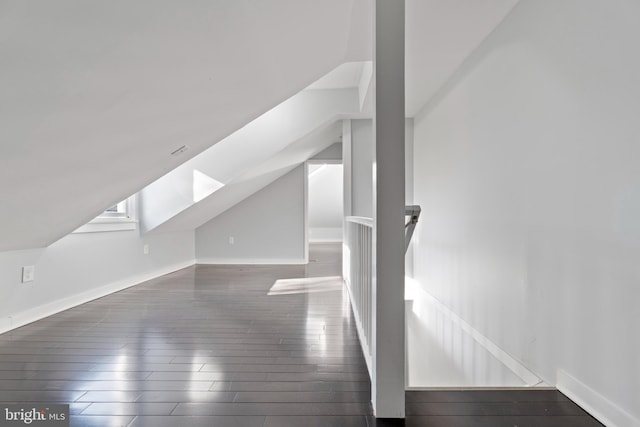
0,0 -> 516,251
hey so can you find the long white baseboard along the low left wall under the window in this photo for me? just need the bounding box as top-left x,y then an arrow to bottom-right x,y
0,260 -> 194,334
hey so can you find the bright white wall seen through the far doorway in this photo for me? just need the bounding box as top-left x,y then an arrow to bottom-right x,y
308,165 -> 343,242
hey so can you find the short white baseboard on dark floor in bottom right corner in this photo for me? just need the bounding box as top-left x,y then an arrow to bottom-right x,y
556,369 -> 640,427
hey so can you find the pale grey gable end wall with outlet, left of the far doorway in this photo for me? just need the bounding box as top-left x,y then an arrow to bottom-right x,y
196,166 -> 306,264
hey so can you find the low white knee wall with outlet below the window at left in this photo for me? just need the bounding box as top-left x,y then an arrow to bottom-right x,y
0,230 -> 195,332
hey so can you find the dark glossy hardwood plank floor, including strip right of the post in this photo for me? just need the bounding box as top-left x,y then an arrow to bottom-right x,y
0,245 -> 600,427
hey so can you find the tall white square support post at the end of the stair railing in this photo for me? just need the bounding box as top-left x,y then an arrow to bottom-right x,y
372,0 -> 405,418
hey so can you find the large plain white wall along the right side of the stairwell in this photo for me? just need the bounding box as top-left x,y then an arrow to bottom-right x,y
414,0 -> 640,427
